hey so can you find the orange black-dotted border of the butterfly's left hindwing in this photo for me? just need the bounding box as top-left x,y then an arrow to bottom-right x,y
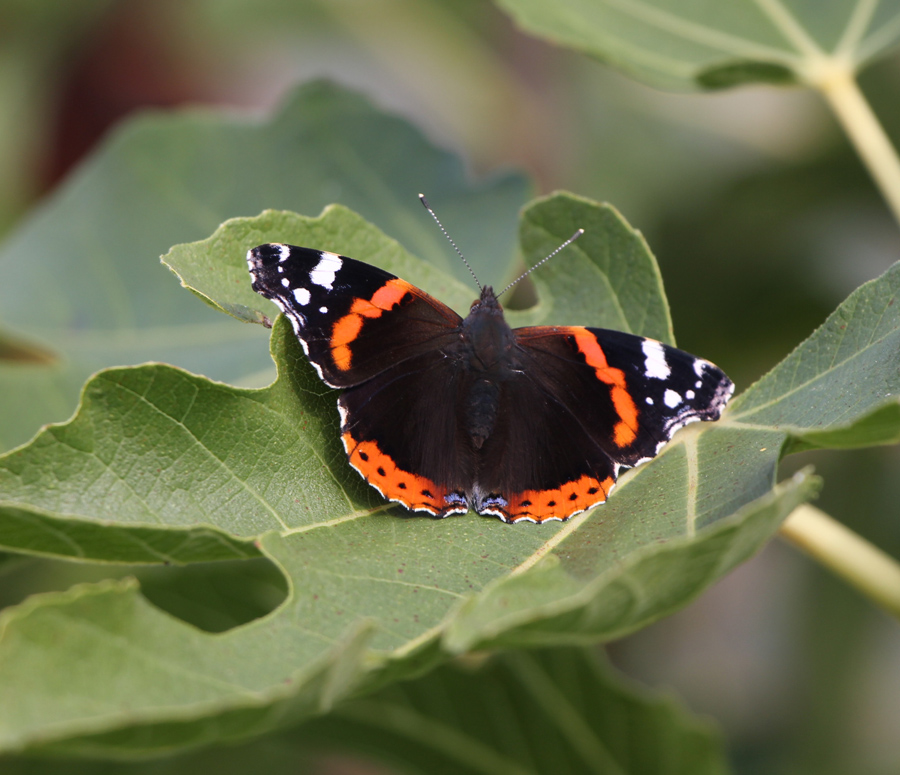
341,432 -> 469,517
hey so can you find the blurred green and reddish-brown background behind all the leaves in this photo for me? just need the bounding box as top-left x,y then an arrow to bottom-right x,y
0,0 -> 900,775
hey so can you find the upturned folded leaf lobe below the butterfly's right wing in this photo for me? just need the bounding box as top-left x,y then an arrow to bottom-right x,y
444,467 -> 818,652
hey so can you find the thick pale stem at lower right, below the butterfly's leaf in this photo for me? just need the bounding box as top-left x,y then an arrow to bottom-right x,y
780,504 -> 900,619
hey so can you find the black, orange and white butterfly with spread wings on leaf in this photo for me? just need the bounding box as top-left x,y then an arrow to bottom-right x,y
247,198 -> 734,522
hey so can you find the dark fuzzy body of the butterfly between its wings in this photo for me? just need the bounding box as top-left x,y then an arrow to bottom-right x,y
460,286 -> 515,449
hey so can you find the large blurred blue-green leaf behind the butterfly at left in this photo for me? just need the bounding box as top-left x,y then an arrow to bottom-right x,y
0,83 -> 528,449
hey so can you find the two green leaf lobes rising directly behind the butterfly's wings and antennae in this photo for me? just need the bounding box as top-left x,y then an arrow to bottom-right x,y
169,193 -> 674,342
